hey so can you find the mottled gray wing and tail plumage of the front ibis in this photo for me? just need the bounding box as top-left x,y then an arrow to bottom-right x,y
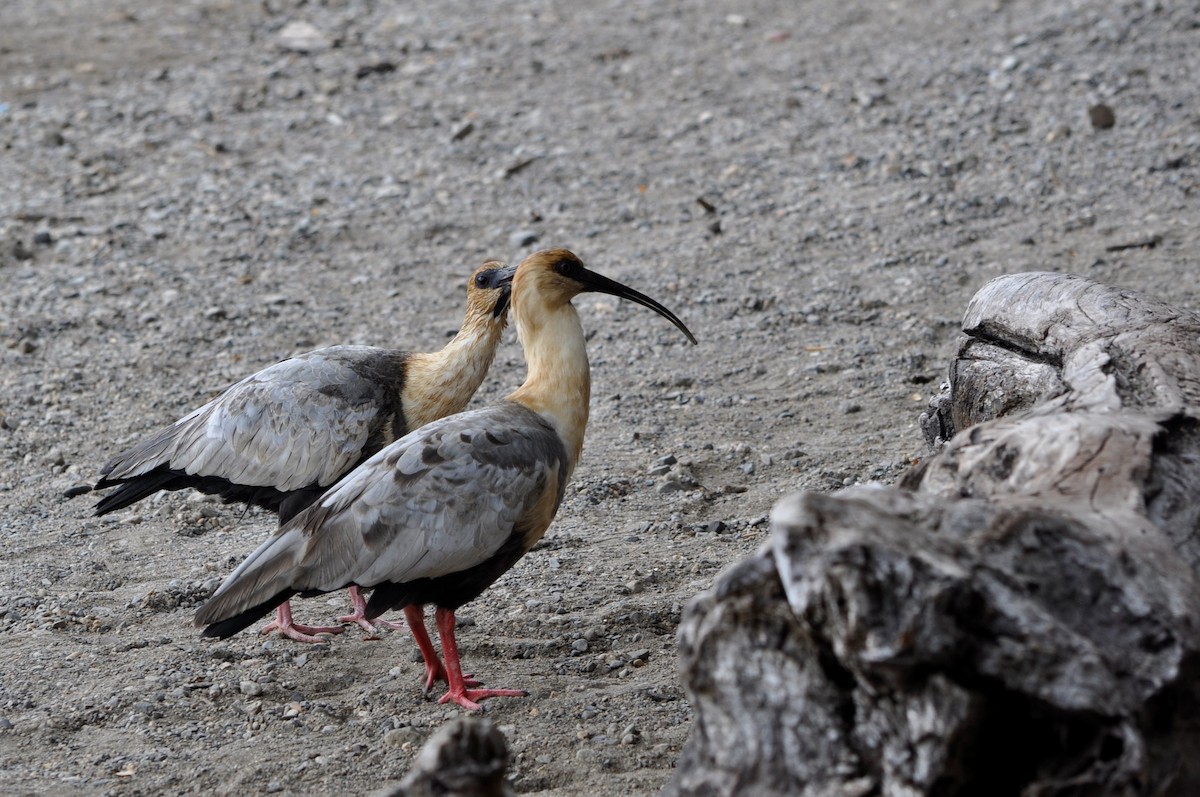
197,401 -> 569,625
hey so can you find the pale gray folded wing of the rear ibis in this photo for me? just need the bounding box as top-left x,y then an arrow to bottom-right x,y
103,346 -> 400,491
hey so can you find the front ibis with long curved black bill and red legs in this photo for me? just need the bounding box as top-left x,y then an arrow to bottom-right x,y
196,250 -> 696,709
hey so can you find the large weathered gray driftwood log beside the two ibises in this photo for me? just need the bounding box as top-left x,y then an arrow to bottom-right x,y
664,274 -> 1200,797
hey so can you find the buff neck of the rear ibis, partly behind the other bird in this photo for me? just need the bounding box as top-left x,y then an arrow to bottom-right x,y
402,313 -> 504,430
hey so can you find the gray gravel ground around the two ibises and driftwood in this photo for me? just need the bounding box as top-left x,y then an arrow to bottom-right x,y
0,0 -> 1200,797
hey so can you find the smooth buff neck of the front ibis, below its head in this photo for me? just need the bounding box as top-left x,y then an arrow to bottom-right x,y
509,301 -> 592,475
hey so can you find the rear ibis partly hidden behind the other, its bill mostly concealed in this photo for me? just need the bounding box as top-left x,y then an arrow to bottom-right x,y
88,260 -> 515,642
